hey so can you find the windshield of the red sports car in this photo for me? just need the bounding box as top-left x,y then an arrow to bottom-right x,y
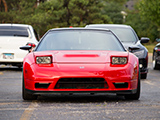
36,30 -> 124,51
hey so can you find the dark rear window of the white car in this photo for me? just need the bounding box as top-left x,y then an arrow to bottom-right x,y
0,26 -> 29,37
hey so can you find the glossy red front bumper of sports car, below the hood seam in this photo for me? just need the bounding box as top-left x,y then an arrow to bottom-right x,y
23,64 -> 139,94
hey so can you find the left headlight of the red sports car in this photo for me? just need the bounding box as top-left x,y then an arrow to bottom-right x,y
36,56 -> 52,64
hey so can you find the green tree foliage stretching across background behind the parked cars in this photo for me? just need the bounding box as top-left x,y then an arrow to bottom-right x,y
0,0 -> 160,42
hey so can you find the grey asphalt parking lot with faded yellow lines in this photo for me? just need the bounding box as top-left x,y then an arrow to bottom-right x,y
0,54 -> 160,120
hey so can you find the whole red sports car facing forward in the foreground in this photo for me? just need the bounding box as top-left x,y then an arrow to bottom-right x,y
20,28 -> 140,100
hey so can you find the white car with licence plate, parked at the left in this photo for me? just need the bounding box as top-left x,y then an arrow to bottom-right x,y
0,24 -> 38,67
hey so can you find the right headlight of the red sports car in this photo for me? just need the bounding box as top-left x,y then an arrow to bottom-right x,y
112,57 -> 127,65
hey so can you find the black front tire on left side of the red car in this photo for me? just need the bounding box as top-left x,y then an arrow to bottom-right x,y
22,78 -> 38,100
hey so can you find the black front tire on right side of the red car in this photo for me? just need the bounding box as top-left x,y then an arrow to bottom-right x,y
125,71 -> 141,100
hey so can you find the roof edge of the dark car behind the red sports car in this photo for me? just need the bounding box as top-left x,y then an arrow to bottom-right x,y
86,24 -> 131,28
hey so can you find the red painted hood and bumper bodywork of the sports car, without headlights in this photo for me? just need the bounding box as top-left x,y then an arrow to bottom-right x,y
23,51 -> 139,92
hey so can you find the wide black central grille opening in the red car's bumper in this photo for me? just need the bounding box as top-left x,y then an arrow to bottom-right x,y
55,78 -> 108,89
